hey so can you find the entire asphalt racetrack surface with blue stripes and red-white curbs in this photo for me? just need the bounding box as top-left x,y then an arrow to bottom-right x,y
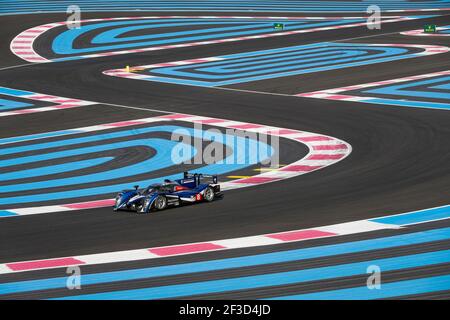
0,1 -> 450,299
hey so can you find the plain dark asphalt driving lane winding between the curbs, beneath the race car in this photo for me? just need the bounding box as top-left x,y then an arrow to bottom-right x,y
0,13 -> 450,298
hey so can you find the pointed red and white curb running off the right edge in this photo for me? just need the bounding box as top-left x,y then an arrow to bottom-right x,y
295,70 -> 450,101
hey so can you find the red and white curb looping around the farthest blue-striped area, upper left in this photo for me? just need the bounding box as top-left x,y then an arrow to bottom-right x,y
10,16 -> 415,63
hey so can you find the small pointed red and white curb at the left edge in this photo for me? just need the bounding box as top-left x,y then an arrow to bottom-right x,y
0,92 -> 97,117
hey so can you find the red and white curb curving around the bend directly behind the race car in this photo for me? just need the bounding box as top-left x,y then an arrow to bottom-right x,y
2,113 -> 352,218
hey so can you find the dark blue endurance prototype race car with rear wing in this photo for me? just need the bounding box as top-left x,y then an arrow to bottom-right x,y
114,172 -> 223,213
